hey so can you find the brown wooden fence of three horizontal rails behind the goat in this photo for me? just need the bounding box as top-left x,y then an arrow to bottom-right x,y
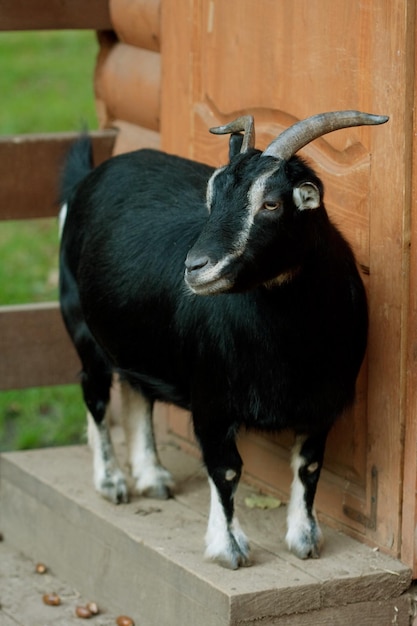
0,0 -> 116,389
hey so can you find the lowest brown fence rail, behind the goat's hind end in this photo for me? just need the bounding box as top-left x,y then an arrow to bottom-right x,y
0,302 -> 81,390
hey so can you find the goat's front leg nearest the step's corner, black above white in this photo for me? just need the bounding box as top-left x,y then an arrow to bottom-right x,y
197,432 -> 249,569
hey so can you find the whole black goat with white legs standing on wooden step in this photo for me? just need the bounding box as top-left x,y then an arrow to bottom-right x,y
60,111 -> 388,568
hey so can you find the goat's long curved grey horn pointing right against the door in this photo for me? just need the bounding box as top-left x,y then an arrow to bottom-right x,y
262,111 -> 389,160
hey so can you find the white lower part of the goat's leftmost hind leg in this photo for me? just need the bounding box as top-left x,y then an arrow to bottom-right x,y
87,409 -> 129,504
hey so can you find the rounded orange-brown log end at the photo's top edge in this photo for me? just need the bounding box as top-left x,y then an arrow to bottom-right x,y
110,0 -> 161,52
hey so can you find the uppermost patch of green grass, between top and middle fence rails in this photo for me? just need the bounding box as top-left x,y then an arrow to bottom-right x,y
0,31 -> 98,135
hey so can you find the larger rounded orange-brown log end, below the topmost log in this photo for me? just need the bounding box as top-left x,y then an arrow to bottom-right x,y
95,43 -> 160,131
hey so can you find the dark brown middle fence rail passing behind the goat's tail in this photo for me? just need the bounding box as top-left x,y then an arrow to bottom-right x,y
0,130 -> 116,220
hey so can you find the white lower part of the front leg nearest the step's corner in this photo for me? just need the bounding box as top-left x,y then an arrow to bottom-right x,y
205,477 -> 249,569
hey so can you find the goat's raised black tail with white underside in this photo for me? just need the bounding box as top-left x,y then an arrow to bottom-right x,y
59,133 -> 93,238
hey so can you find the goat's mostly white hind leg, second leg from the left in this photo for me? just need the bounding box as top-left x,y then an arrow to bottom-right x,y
120,381 -> 174,499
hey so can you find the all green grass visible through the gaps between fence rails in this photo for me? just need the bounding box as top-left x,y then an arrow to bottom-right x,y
0,31 -> 98,451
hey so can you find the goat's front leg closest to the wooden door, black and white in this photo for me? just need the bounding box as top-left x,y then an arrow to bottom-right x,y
286,432 -> 327,559
